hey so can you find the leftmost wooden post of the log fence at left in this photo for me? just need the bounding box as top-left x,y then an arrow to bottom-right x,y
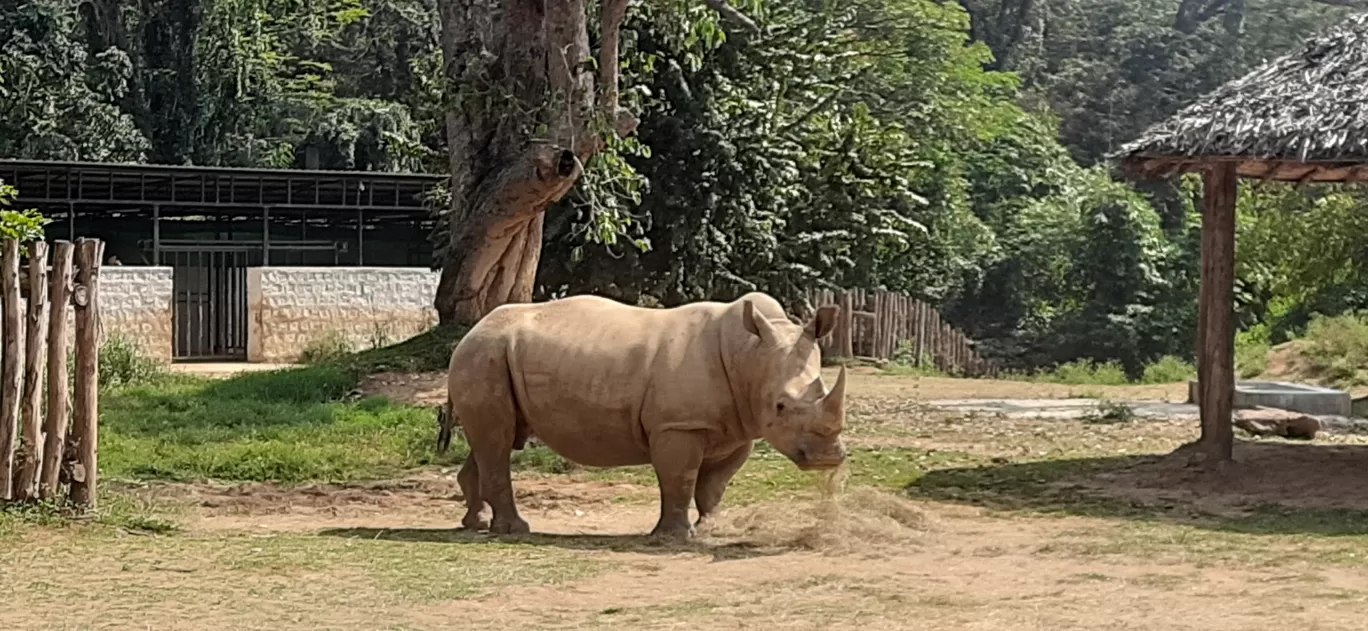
0,240 -> 23,501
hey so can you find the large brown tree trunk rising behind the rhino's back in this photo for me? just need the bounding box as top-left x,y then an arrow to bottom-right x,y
436,0 -> 601,324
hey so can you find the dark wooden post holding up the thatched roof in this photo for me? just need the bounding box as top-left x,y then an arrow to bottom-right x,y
1197,163 -> 1238,467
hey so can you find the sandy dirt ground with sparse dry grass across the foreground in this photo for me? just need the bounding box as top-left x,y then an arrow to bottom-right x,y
8,472 -> 1368,631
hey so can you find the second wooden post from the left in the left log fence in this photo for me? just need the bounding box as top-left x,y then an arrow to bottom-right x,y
14,241 -> 48,500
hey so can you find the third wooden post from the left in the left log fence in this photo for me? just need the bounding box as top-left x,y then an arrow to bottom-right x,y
38,241 -> 75,500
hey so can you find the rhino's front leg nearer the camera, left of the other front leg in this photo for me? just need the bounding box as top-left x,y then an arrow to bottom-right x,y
651,430 -> 705,539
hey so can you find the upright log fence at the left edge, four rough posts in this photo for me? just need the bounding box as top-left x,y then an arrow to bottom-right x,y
0,240 -> 104,508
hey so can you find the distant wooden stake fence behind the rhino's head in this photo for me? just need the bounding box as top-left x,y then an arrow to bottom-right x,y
808,289 -> 999,376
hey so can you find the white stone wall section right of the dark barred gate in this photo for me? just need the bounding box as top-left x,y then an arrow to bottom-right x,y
248,267 -> 440,361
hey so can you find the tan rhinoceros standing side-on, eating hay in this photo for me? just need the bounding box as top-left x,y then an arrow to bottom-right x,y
438,293 -> 845,539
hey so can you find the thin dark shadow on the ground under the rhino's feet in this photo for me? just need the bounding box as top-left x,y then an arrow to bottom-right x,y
319,528 -> 785,561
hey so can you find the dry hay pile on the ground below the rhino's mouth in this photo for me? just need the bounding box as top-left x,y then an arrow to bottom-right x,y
709,465 -> 928,554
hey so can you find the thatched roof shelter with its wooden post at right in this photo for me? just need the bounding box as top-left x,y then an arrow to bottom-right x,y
1114,14 -> 1368,465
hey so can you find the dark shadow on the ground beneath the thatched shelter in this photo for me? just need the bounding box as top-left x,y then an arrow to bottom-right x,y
907,441 -> 1368,535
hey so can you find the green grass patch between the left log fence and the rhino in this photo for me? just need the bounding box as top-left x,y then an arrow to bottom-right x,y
100,365 -> 464,482
